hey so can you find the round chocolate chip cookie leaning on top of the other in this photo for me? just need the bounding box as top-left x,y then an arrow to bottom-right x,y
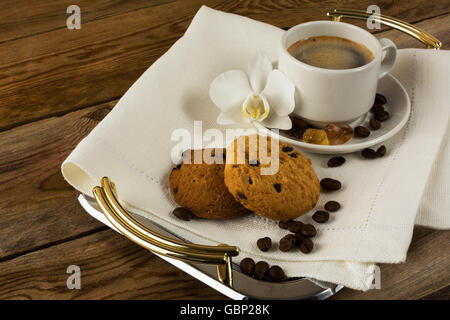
225,135 -> 320,221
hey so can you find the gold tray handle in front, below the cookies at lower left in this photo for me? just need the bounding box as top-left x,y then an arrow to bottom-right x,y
93,177 -> 239,288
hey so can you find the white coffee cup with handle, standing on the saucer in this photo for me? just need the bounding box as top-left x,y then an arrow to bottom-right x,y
278,21 -> 397,126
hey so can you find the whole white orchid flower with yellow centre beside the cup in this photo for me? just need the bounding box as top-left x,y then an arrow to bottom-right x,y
209,53 -> 295,130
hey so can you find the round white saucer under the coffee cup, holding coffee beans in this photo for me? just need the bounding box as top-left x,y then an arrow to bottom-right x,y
254,74 -> 411,154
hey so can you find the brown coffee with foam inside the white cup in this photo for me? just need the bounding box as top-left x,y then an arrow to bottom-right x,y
288,36 -> 374,70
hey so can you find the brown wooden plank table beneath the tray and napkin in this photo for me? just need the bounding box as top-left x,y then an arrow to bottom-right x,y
0,0 -> 450,299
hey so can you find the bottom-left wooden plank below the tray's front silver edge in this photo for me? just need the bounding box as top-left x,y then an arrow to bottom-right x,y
0,230 -> 223,299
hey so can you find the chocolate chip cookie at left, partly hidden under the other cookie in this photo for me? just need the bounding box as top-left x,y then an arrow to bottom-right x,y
169,149 -> 249,219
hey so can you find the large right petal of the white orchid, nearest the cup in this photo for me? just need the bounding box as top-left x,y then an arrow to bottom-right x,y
261,70 -> 295,117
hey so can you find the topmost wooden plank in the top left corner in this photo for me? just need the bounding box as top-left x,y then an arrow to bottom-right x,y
0,0 -> 175,43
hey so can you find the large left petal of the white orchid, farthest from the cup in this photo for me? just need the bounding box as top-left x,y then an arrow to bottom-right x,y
209,70 -> 251,112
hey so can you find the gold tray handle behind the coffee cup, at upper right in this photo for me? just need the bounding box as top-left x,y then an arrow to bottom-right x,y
327,9 -> 442,50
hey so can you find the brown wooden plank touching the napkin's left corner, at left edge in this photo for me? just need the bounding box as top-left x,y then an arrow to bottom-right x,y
0,101 -> 115,261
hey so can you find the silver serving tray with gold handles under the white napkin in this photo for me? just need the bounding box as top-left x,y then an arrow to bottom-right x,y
78,9 -> 441,300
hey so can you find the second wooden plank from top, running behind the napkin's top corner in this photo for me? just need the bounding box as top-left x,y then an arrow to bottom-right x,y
0,0 -> 448,130
